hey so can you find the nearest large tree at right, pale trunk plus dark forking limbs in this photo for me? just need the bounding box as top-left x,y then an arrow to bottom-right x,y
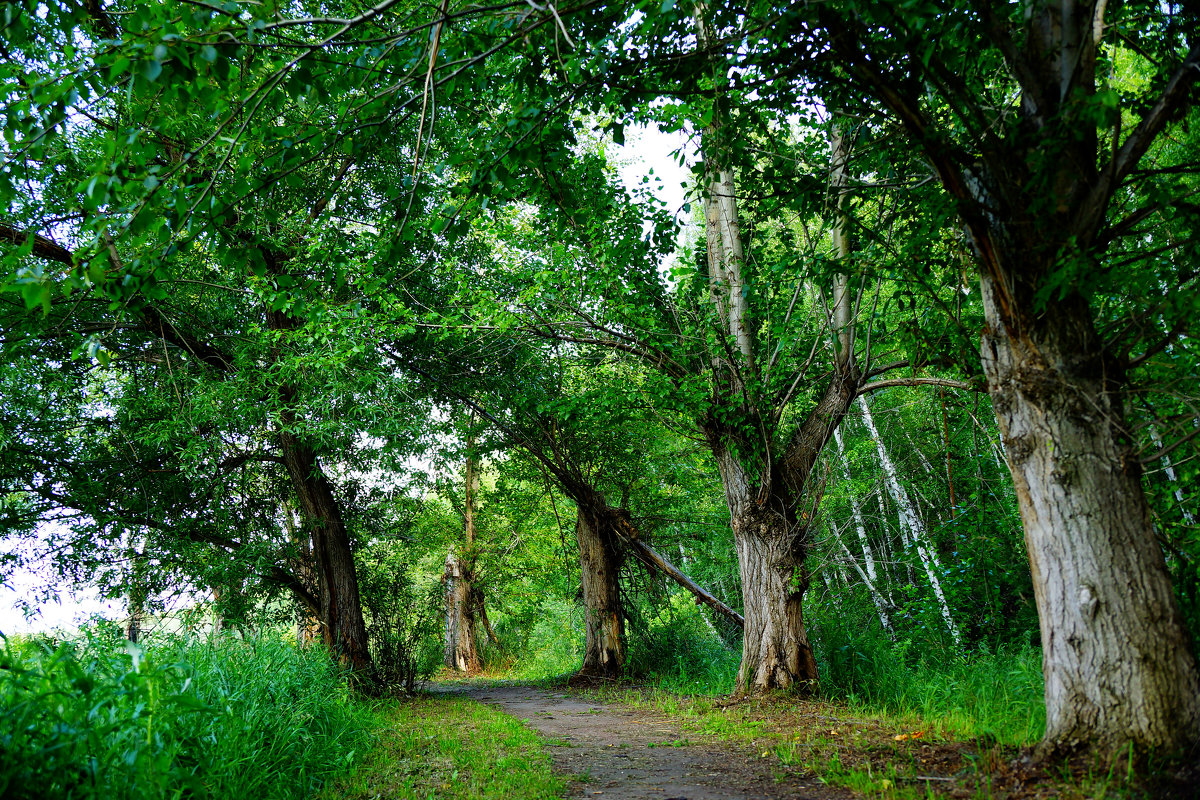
823,2 -> 1200,751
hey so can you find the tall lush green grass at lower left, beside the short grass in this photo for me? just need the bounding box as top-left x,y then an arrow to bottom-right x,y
0,634 -> 368,800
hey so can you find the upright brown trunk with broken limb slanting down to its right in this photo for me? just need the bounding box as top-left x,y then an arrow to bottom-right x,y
575,506 -> 625,678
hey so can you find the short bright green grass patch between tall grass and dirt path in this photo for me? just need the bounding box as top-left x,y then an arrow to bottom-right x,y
320,694 -> 566,800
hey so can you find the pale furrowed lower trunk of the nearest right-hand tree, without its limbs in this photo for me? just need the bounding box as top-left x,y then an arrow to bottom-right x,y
983,278 -> 1200,751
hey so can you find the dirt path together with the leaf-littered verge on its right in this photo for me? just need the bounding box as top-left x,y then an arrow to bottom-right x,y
415,680 -> 1200,800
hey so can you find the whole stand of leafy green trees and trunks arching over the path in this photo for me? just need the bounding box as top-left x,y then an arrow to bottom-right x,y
0,0 -> 1200,786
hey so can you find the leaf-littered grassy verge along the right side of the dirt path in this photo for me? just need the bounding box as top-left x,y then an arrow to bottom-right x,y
576,687 -> 1166,800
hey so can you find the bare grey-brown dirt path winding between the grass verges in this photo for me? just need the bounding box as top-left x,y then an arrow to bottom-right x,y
438,686 -> 852,800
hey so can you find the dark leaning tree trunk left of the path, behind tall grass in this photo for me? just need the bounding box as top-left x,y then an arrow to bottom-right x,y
280,428 -> 372,681
